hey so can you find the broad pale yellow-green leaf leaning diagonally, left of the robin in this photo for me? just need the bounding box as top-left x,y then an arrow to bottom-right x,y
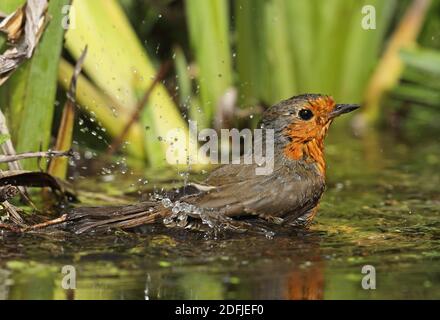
66,0 -> 187,163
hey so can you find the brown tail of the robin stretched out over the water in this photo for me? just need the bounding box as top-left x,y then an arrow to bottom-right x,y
66,201 -> 167,234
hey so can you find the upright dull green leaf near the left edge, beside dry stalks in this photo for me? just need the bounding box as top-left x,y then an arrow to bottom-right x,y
2,0 -> 70,169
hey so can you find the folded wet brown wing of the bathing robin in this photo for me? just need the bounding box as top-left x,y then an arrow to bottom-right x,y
181,159 -> 324,219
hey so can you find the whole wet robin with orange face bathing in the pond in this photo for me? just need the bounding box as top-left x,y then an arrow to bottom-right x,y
68,94 -> 359,233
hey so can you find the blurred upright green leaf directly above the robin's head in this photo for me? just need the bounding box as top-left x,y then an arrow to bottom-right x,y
235,0 -> 298,106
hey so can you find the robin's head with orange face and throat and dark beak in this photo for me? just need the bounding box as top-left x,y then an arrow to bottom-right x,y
263,94 -> 359,175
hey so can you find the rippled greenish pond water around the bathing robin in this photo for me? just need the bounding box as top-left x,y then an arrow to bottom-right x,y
0,126 -> 440,299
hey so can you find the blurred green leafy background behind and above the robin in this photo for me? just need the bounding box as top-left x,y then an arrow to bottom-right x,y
0,0 -> 440,175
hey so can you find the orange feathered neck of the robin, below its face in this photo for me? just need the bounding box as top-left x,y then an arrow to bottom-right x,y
284,139 -> 325,176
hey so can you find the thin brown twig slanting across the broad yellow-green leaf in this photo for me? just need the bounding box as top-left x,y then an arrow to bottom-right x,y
107,61 -> 171,155
